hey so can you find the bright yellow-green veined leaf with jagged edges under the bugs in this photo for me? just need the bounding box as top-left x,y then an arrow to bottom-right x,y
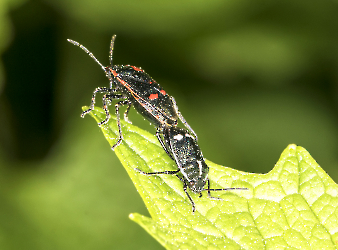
84,107 -> 338,250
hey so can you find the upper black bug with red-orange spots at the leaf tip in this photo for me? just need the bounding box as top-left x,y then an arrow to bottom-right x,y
67,35 -> 197,150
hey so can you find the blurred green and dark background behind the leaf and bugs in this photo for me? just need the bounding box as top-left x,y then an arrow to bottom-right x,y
0,0 -> 338,249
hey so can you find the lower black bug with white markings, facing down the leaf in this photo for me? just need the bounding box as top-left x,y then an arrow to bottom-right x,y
135,127 -> 248,212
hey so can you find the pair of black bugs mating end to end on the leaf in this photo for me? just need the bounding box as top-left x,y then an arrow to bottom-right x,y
68,35 -> 245,211
